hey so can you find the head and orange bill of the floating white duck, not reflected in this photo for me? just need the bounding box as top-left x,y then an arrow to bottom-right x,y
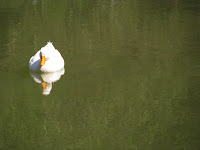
40,42 -> 55,66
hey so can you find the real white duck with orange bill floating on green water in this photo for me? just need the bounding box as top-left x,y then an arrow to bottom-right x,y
29,42 -> 65,72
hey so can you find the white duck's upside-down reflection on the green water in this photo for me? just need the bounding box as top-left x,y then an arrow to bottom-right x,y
30,68 -> 65,95
